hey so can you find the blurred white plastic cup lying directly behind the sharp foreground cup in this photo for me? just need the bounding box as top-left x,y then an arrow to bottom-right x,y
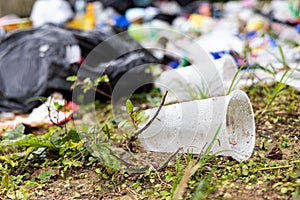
155,55 -> 237,104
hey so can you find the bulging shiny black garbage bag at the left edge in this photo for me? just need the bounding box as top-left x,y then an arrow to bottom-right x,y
0,26 -> 77,112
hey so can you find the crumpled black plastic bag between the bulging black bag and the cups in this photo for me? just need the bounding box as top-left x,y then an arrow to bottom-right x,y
70,26 -> 161,101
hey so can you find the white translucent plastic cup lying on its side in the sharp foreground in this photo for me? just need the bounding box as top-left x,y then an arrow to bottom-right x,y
139,90 -> 255,161
